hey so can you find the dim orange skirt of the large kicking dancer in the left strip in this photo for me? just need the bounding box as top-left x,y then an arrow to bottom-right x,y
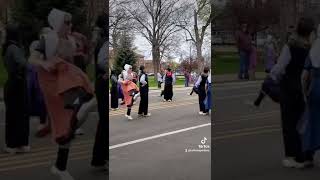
38,61 -> 93,141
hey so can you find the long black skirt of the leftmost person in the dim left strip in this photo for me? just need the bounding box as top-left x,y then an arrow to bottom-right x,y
4,79 -> 30,148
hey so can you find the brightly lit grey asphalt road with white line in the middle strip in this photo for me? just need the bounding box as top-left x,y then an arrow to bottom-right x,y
109,88 -> 211,180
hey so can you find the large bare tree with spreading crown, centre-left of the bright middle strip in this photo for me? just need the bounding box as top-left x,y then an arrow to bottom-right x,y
124,0 -> 189,77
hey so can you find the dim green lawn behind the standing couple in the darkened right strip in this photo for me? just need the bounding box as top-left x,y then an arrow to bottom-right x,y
211,52 -> 264,75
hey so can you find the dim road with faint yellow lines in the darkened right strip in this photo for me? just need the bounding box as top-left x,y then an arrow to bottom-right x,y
212,82 -> 320,180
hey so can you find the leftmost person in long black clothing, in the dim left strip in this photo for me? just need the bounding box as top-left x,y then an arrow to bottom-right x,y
2,25 -> 30,153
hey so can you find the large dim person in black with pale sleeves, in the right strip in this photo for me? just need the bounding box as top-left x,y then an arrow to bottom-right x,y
270,18 -> 315,168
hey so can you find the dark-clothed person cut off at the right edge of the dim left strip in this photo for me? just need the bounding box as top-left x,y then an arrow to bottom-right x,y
91,14 -> 109,170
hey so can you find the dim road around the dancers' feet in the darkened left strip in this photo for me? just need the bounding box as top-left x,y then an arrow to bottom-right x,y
0,104 -> 108,180
